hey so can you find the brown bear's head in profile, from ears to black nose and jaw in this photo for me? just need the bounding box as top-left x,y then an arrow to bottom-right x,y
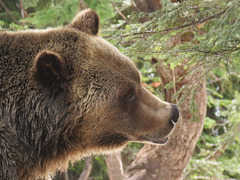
32,9 -> 179,156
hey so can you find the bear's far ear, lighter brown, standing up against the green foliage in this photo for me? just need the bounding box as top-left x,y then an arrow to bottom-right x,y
69,9 -> 99,35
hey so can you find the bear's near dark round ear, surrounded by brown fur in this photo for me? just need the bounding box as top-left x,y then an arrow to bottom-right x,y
32,50 -> 66,81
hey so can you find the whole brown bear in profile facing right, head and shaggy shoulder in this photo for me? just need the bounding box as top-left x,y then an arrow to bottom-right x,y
0,9 -> 179,180
